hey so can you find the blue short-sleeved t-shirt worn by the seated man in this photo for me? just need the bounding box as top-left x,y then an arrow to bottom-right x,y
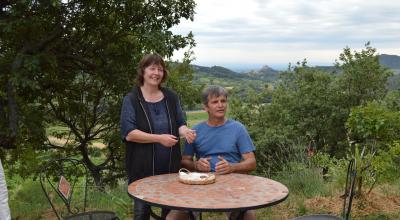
183,119 -> 255,172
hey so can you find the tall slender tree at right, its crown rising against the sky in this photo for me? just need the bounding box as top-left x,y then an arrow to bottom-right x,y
329,42 -> 393,156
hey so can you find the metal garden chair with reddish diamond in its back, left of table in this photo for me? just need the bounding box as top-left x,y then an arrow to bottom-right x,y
40,158 -> 118,220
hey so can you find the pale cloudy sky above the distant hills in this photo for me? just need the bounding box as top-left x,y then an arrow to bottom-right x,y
172,0 -> 400,70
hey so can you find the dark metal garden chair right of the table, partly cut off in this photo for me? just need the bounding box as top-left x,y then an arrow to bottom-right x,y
293,159 -> 357,220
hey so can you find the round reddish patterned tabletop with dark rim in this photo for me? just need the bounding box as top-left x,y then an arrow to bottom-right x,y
128,173 -> 289,211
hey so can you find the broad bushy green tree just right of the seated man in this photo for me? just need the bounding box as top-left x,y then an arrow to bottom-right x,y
233,62 -> 333,174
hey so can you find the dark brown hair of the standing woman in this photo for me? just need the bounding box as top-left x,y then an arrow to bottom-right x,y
136,53 -> 168,86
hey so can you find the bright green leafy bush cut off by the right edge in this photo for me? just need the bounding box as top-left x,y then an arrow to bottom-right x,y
346,100 -> 400,188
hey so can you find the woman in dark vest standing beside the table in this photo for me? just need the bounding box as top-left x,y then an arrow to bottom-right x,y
121,54 -> 196,219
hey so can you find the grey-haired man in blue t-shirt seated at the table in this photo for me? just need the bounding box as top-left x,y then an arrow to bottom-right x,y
168,86 -> 256,220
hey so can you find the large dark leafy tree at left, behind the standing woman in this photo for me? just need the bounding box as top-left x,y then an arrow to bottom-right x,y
0,0 -> 195,184
